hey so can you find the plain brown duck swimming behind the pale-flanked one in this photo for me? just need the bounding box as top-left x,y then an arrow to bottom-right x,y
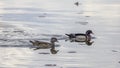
30,37 -> 58,49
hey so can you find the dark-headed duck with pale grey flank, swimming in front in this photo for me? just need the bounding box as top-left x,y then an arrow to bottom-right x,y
65,30 -> 93,42
